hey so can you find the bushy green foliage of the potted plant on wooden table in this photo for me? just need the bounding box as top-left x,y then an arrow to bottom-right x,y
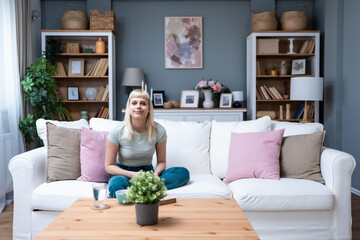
126,170 -> 166,204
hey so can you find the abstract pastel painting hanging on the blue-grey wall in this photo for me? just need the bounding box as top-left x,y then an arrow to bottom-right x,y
165,17 -> 203,69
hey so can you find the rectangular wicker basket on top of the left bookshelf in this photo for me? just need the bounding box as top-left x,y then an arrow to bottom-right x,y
90,10 -> 115,30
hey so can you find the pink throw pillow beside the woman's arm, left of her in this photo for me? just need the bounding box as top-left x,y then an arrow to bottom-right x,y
76,127 -> 110,182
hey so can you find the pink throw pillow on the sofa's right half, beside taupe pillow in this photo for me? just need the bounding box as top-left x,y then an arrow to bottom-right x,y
224,129 -> 285,183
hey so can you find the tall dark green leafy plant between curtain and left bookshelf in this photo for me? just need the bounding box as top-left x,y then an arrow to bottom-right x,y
19,56 -> 66,144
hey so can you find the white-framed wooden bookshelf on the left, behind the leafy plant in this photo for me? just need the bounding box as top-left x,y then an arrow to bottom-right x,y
41,30 -> 116,120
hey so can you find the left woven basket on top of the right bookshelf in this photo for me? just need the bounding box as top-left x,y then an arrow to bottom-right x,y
251,10 -> 278,32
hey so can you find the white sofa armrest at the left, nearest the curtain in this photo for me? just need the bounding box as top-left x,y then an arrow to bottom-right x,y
9,147 -> 47,239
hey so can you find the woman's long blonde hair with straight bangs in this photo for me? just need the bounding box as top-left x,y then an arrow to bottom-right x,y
124,89 -> 156,142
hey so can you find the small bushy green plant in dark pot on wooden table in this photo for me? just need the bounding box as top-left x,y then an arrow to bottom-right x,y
126,171 -> 166,226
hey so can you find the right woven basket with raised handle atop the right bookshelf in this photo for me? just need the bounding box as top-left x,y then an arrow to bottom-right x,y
280,4 -> 308,31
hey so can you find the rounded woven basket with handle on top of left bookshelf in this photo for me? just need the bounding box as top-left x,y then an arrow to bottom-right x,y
60,3 -> 88,30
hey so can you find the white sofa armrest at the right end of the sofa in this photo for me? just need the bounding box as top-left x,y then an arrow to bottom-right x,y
320,148 -> 356,239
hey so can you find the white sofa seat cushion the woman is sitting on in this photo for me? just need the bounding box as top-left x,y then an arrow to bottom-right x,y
32,174 -> 232,211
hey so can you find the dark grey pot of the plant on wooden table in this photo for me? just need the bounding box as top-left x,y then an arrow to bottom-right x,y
135,203 -> 159,226
